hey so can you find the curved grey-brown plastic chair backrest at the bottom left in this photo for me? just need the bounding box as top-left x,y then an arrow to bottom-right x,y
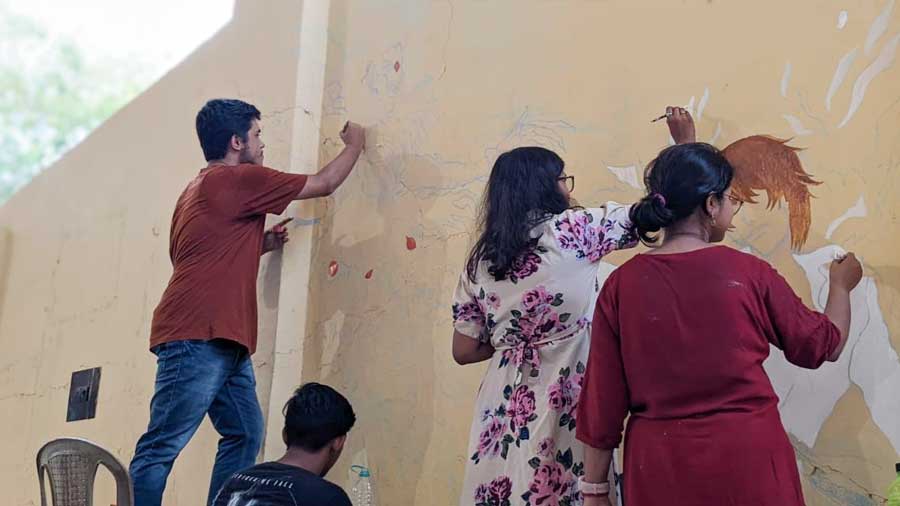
37,438 -> 134,506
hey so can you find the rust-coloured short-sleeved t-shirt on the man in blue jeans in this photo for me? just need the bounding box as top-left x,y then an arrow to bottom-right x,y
150,164 -> 306,353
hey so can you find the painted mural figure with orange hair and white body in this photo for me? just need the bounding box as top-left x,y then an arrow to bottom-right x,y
724,136 -> 900,452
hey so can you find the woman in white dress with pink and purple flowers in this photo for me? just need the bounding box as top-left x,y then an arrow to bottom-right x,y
453,107 -> 694,506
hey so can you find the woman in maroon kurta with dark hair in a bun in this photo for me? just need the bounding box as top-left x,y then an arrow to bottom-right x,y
577,143 -> 862,506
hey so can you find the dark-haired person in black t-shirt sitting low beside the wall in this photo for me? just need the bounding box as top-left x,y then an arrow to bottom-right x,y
214,383 -> 356,506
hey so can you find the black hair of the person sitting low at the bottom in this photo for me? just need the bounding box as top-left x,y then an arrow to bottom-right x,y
283,383 -> 356,452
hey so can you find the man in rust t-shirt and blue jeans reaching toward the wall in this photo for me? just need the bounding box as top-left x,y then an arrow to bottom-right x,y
130,99 -> 365,506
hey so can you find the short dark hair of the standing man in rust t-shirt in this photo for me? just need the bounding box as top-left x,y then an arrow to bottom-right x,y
197,98 -> 260,161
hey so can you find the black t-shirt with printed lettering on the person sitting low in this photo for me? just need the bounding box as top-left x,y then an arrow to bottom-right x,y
213,462 -> 352,506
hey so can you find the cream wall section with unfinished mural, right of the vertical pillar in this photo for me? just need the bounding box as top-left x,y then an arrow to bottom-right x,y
307,0 -> 900,506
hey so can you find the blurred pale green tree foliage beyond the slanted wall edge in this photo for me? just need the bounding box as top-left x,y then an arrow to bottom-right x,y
0,2 -> 142,202
